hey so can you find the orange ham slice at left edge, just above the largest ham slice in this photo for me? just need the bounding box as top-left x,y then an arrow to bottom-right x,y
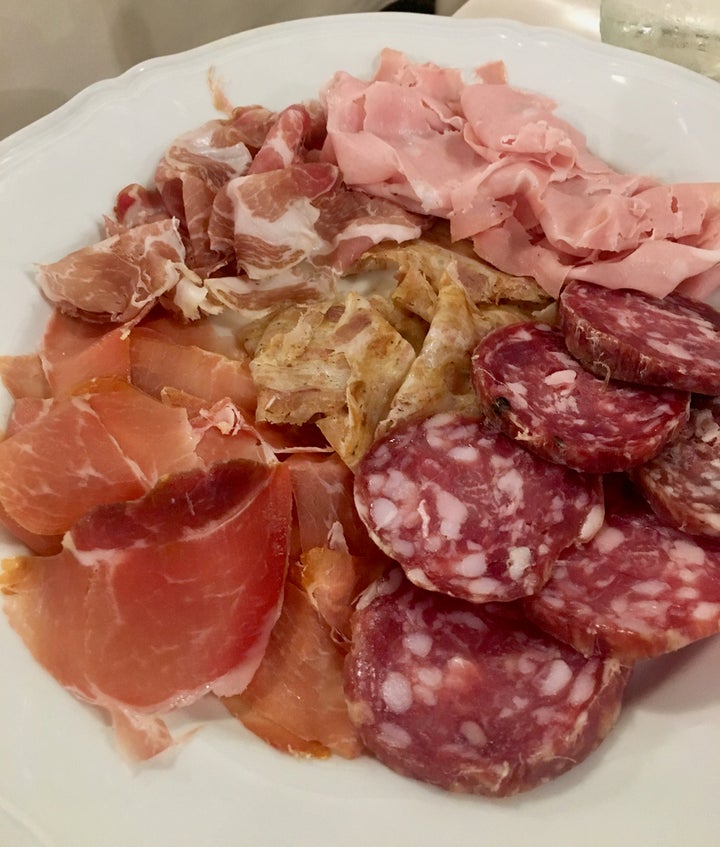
0,385 -> 200,535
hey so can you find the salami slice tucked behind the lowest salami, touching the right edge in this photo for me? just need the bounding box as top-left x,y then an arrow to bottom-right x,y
524,500 -> 720,662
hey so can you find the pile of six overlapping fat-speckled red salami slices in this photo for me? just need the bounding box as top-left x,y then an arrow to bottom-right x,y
352,274 -> 720,796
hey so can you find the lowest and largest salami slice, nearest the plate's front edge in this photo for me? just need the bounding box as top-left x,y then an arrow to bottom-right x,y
344,571 -> 630,797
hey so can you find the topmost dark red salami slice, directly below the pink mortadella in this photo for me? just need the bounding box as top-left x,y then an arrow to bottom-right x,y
558,281 -> 720,396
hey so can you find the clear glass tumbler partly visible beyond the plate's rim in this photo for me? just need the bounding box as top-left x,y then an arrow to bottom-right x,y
600,0 -> 720,80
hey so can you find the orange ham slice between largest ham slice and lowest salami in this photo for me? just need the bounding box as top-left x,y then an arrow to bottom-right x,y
223,582 -> 362,759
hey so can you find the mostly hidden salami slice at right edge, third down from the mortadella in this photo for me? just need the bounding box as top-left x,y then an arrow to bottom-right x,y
633,397 -> 720,538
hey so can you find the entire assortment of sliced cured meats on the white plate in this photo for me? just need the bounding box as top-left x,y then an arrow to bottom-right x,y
0,50 -> 720,797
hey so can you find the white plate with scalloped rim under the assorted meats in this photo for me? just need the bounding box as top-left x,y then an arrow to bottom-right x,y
0,14 -> 720,847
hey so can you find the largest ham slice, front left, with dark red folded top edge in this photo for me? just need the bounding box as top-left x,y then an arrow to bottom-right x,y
5,461 -> 291,758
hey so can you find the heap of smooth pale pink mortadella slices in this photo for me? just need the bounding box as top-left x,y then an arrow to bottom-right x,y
323,50 -> 720,297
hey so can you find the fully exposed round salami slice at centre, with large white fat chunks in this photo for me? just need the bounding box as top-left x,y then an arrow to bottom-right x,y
355,413 -> 603,602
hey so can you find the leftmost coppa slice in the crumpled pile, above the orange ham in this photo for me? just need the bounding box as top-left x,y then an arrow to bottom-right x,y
37,218 -> 194,323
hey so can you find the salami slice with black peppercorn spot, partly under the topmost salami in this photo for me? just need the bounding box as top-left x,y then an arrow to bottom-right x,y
473,323 -> 690,473
